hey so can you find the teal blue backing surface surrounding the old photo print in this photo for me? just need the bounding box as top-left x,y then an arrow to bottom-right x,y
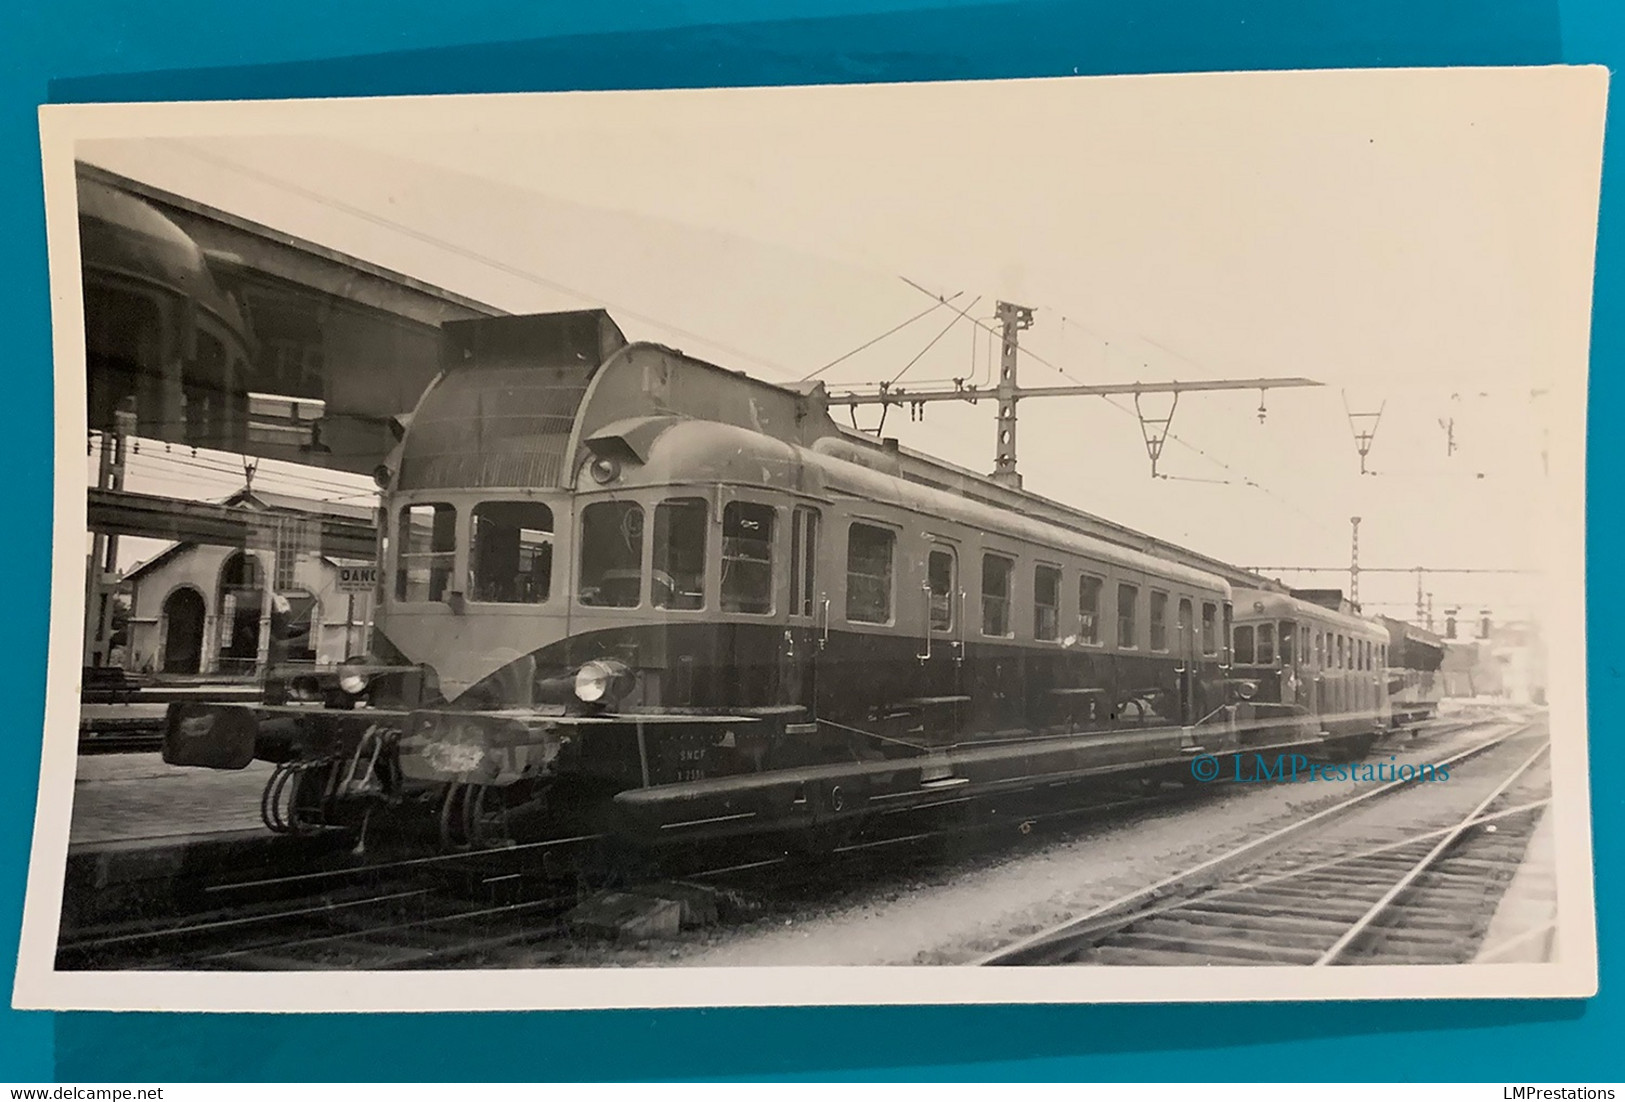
0,0 -> 1625,1082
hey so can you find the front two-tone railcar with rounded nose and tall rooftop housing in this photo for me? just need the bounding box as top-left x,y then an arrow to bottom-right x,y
164,310 -> 1378,845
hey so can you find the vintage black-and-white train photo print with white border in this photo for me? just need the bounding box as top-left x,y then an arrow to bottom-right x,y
16,68 -> 1606,1009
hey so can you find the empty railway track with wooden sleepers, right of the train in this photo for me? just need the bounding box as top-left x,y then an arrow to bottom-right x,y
977,723 -> 1550,965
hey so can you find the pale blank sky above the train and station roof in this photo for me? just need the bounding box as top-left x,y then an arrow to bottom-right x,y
66,68 -> 1602,618
